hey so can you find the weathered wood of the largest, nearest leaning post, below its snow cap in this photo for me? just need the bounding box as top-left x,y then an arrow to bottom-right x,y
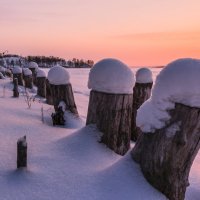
131,103 -> 200,200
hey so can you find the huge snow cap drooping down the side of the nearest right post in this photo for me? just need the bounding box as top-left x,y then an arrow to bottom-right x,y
136,58 -> 200,132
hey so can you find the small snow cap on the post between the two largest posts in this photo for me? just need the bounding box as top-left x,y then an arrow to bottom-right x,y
136,67 -> 153,83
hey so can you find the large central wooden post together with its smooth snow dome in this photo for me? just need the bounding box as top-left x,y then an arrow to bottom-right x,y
86,59 -> 134,155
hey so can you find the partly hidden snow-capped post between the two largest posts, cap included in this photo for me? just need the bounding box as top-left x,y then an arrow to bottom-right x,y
131,68 -> 153,141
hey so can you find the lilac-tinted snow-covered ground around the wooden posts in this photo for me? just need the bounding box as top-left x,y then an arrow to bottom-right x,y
0,68 -> 200,200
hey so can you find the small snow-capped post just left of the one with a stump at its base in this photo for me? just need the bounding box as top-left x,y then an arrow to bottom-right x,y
36,69 -> 46,98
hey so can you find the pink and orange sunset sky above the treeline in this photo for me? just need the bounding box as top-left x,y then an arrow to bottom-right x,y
0,0 -> 200,66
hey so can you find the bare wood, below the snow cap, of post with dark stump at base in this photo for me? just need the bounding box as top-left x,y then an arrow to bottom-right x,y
50,83 -> 78,114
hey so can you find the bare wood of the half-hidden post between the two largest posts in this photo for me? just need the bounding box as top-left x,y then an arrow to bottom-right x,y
131,82 -> 153,141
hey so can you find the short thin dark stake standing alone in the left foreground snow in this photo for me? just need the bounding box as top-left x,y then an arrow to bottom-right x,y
17,136 -> 27,168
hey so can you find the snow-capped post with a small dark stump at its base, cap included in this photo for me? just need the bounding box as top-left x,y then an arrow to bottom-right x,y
48,65 -> 78,114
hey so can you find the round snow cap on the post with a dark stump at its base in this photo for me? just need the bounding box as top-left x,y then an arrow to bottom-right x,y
48,65 -> 70,85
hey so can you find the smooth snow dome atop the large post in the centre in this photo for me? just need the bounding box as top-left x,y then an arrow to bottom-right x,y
88,58 -> 135,94
